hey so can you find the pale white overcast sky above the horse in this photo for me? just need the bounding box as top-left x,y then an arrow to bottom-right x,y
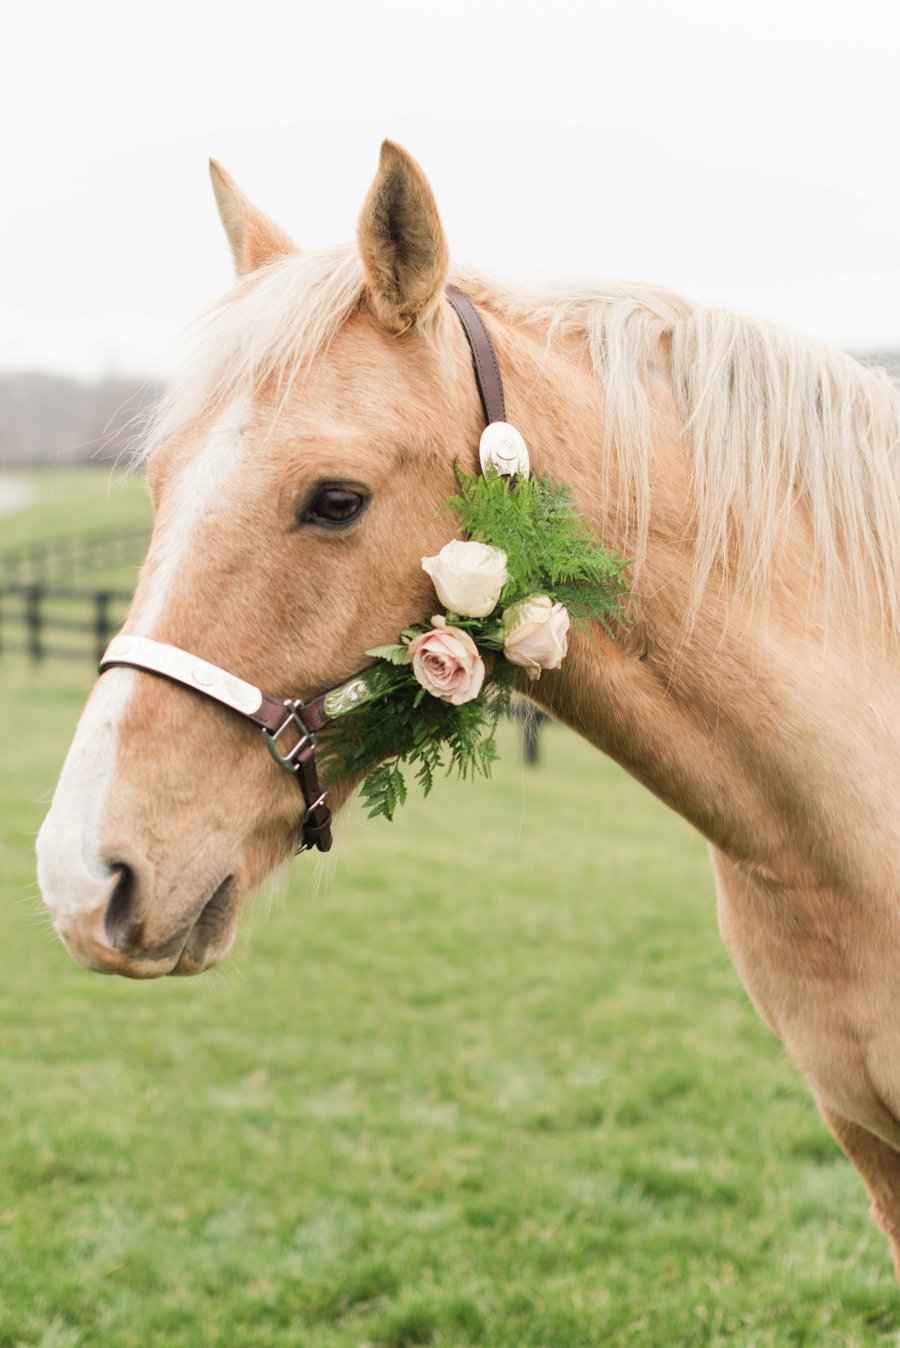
0,0 -> 900,376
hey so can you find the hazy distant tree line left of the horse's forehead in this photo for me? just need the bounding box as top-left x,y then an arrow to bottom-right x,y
0,373 -> 160,468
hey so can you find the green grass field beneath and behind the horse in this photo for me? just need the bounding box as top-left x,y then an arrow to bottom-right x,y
0,472 -> 900,1348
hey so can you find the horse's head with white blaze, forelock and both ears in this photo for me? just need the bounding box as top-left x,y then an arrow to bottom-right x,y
38,143 -> 498,977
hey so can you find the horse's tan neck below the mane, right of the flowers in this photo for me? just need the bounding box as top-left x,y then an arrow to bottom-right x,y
487,308 -> 900,883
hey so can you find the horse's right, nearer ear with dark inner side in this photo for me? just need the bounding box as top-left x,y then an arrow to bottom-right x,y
357,140 -> 449,332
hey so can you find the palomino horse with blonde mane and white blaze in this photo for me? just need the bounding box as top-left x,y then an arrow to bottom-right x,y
38,144 -> 900,1267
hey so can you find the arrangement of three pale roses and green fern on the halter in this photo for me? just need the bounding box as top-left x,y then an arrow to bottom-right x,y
322,468 -> 628,820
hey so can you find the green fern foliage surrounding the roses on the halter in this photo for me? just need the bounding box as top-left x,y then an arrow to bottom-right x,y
323,469 -> 628,820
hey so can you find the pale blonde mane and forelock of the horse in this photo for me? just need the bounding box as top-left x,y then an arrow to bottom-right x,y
140,244 -> 900,632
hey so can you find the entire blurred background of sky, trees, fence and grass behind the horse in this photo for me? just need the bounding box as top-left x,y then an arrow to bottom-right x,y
0,0 -> 900,1348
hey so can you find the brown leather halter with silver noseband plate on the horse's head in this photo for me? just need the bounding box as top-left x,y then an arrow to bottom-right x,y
98,286 -> 507,852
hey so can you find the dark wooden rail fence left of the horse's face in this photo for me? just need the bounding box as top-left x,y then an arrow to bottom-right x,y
0,531 -> 147,662
